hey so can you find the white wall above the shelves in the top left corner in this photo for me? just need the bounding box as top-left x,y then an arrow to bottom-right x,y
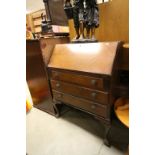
26,0 -> 45,13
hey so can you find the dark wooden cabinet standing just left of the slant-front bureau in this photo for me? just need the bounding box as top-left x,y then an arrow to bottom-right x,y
26,37 -> 69,115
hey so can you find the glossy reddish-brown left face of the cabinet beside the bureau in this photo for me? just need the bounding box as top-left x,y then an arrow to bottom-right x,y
26,40 -> 54,114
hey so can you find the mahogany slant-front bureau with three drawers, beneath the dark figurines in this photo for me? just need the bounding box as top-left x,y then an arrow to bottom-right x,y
48,42 -> 121,124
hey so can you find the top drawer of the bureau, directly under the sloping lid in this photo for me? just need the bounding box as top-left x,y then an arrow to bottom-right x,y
51,71 -> 104,90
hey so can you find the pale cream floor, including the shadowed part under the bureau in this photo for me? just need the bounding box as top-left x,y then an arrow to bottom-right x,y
26,108 -> 124,155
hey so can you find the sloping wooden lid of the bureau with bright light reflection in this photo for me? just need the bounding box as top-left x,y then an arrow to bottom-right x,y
48,42 -> 119,75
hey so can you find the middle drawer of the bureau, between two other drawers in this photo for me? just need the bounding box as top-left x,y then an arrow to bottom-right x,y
51,80 -> 108,104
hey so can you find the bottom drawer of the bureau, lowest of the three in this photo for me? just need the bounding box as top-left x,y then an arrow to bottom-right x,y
53,91 -> 108,118
